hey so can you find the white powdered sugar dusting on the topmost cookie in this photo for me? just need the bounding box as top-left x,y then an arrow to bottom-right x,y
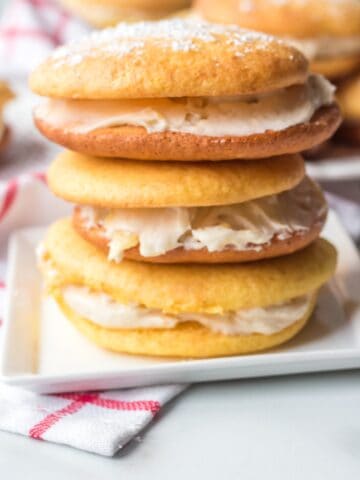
51,19 -> 281,67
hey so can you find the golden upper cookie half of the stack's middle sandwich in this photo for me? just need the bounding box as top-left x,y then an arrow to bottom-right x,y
48,151 -> 305,208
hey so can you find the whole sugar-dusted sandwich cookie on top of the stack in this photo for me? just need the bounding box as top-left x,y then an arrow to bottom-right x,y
30,19 -> 340,161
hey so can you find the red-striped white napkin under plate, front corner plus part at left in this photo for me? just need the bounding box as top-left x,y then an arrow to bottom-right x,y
0,173 -> 185,455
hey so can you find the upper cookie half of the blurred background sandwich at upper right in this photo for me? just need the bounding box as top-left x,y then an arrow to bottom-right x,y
195,0 -> 360,38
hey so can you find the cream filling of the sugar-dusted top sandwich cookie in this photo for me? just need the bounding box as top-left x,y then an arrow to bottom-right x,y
35,75 -> 335,136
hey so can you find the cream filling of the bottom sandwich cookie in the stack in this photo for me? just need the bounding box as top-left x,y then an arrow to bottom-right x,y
62,286 -> 313,335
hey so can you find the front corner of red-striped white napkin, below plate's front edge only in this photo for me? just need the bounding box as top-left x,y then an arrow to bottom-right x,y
0,385 -> 183,456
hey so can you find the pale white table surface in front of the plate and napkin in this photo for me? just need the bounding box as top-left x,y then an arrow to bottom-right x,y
0,372 -> 360,480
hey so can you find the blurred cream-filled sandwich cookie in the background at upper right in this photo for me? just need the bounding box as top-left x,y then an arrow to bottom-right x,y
195,0 -> 360,78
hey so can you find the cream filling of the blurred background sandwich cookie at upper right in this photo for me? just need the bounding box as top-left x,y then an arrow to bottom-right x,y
287,36 -> 360,60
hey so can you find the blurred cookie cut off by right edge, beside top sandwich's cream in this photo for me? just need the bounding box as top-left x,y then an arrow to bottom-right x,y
335,74 -> 360,145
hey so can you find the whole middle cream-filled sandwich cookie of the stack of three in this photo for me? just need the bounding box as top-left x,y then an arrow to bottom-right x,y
48,152 -> 327,263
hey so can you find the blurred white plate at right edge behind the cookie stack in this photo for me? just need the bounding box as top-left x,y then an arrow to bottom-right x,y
306,153 -> 360,182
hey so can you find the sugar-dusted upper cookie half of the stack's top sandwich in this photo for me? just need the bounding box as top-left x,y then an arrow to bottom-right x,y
30,19 -> 308,99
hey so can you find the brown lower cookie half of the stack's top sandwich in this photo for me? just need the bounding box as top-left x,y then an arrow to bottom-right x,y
35,104 -> 341,161
